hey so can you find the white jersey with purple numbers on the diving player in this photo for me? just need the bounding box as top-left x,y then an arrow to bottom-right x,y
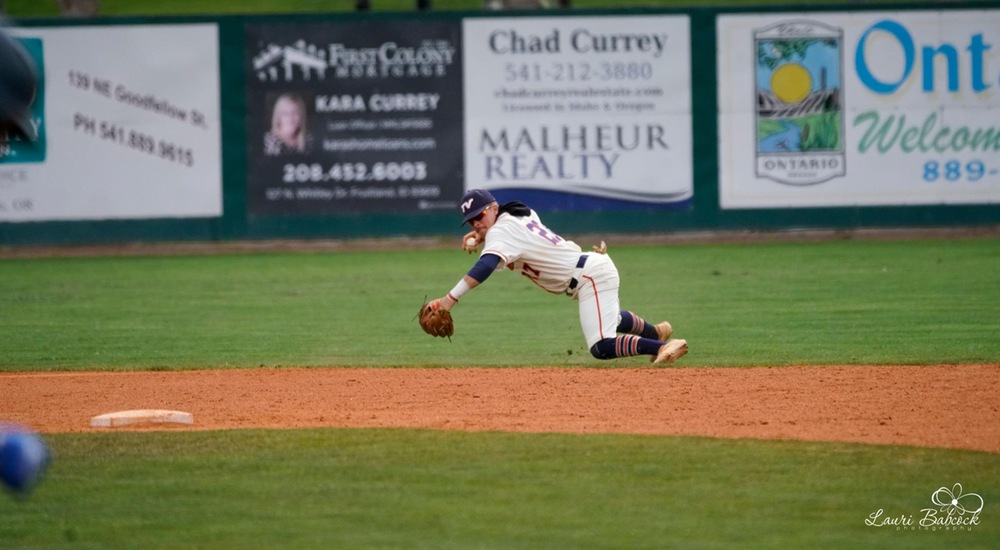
483,210 -> 581,294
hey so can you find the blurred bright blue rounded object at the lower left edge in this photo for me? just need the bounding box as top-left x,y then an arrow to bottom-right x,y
0,425 -> 51,495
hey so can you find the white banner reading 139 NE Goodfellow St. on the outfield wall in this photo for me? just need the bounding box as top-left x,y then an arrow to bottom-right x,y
0,24 -> 222,222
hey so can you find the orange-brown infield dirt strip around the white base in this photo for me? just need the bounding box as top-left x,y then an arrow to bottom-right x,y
0,364 -> 1000,453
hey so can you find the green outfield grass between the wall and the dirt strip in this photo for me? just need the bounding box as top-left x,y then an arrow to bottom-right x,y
0,239 -> 1000,370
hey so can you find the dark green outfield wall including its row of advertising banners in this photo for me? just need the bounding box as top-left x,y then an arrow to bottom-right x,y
0,2 -> 1000,245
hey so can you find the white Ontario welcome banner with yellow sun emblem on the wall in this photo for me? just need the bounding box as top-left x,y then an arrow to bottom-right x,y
717,10 -> 1000,209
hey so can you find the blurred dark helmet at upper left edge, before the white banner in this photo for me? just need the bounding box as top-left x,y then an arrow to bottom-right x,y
0,25 -> 38,140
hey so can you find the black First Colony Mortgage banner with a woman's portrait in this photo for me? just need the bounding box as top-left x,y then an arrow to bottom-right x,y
246,21 -> 463,216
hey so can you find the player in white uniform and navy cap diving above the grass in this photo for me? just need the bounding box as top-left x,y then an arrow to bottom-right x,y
429,189 -> 687,364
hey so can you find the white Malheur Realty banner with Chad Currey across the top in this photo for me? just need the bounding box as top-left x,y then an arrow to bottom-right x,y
463,15 -> 693,210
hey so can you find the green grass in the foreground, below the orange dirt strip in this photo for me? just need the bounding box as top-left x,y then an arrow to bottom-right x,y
0,430 -> 1000,549
